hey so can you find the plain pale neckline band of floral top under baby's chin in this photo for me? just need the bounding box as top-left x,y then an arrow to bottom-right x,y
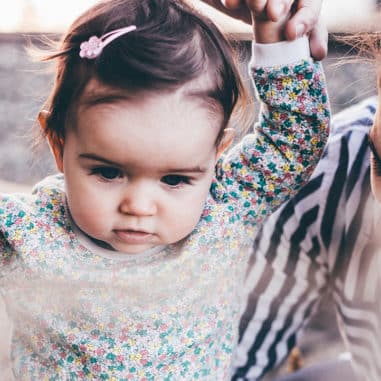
65,199 -> 168,263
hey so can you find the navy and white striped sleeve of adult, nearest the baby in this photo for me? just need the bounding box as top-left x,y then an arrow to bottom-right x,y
232,98 -> 376,380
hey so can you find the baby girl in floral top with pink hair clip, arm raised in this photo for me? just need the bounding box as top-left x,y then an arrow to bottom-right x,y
0,0 -> 329,381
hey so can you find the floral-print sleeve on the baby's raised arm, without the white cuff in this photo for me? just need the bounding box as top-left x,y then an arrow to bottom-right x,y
212,60 -> 330,224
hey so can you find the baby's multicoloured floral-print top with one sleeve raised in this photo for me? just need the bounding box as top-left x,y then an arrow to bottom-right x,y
0,52 -> 329,381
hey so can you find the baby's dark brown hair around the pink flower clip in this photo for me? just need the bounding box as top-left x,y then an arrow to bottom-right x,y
37,0 -> 248,151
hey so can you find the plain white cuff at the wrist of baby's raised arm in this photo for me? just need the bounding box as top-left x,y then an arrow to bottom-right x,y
250,36 -> 311,66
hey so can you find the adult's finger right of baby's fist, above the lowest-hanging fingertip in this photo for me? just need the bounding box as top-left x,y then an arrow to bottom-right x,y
285,0 -> 322,40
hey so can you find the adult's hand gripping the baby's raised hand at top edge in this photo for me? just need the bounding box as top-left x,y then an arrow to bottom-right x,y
203,0 -> 328,60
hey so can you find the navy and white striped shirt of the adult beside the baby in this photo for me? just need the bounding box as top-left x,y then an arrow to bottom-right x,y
232,97 -> 381,381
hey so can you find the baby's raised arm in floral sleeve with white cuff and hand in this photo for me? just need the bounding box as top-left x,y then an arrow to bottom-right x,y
211,0 -> 330,225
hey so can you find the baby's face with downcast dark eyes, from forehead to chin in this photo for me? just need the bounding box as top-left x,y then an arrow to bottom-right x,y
56,86 -> 221,254
